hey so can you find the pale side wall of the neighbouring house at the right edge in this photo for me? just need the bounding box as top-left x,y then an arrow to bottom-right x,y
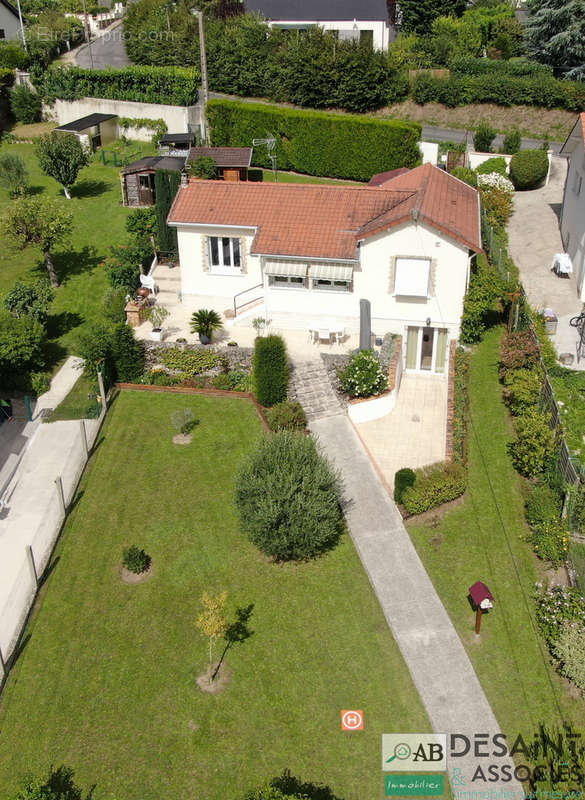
561,140 -> 585,300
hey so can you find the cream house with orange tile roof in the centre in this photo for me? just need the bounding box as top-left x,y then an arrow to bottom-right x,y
168,164 -> 481,374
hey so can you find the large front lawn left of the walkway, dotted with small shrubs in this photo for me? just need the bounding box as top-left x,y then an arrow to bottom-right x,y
0,392 -> 430,800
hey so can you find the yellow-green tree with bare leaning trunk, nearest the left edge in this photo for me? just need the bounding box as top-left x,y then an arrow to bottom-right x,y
1,197 -> 73,287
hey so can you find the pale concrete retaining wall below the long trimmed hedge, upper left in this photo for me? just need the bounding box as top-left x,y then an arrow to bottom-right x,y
44,97 -> 200,142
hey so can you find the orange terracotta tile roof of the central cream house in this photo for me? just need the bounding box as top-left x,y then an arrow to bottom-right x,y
168,165 -> 481,260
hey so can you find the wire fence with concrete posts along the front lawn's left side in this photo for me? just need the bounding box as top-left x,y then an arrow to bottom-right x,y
0,376 -> 108,687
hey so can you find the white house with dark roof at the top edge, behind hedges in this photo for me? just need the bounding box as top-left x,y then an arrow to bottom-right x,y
246,0 -> 395,50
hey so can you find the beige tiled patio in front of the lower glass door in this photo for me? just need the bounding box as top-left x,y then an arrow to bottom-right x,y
358,373 -> 449,486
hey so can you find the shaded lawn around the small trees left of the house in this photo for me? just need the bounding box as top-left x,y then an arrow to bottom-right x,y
0,142 -> 152,367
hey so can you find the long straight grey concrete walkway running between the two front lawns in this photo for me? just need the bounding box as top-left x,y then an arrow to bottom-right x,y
311,416 -> 524,800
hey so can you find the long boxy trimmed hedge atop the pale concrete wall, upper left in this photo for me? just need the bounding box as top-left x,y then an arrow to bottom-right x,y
37,66 -> 200,106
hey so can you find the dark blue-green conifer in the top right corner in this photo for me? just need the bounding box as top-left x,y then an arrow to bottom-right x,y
526,0 -> 585,80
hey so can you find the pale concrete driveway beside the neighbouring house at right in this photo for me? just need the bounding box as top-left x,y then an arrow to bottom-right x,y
508,158 -> 585,369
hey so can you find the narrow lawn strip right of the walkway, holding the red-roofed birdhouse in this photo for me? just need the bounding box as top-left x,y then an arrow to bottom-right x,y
410,328 -> 585,736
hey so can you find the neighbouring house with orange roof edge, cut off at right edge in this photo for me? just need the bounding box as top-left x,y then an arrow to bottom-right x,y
560,112 -> 585,301
